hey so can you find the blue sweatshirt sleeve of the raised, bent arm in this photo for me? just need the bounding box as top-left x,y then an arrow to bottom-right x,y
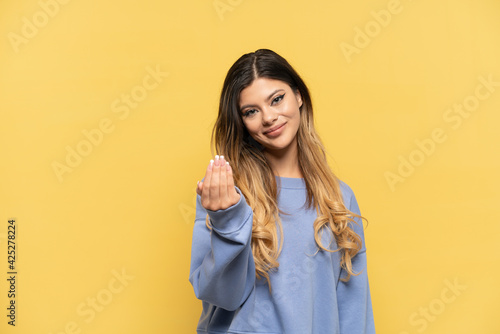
189,187 -> 255,311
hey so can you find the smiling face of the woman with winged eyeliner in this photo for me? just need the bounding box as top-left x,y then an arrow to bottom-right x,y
239,78 -> 302,155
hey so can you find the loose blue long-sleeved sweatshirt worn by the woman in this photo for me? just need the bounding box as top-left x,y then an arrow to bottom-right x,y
189,176 -> 375,334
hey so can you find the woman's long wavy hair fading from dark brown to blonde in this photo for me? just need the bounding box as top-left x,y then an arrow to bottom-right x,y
207,49 -> 365,285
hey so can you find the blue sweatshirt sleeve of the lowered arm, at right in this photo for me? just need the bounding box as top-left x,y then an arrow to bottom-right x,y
337,183 -> 375,334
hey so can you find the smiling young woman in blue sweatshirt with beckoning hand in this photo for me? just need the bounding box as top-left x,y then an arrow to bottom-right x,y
189,49 -> 375,334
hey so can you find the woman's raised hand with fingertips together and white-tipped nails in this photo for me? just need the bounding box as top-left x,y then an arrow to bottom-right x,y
196,155 -> 241,211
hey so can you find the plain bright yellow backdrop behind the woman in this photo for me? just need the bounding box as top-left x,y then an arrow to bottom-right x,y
0,0 -> 500,334
